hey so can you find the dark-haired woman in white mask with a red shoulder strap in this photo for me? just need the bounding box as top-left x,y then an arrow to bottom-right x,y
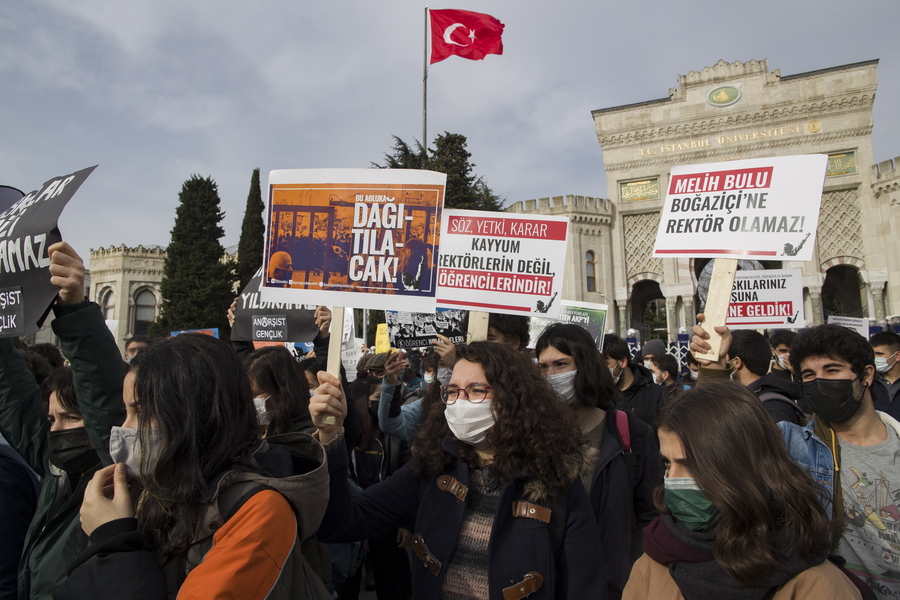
534,323 -> 662,599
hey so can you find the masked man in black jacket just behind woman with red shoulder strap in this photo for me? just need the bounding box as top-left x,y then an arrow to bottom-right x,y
603,333 -> 665,426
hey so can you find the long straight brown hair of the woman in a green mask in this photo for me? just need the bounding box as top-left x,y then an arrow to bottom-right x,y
654,382 -> 833,585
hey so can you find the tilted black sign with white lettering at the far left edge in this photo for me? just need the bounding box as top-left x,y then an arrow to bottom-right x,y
0,166 -> 97,337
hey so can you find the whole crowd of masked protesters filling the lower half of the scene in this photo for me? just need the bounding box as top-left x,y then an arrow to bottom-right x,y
0,242 -> 900,600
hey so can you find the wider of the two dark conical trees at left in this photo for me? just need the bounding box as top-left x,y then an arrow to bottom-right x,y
150,175 -> 234,335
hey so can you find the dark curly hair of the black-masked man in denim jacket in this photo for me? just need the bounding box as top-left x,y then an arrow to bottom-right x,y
791,325 -> 875,376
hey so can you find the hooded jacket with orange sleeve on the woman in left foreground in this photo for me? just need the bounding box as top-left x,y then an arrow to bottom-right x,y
54,433 -> 329,600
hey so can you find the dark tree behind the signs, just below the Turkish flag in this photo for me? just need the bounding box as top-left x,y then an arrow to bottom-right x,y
373,131 -> 503,211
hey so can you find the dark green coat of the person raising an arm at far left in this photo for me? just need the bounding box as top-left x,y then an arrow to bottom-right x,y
0,301 -> 125,600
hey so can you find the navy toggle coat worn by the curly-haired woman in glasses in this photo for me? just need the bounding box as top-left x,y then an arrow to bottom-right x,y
318,439 -> 608,600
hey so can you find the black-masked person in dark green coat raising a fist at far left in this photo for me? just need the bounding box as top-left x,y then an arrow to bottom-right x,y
0,242 -> 125,600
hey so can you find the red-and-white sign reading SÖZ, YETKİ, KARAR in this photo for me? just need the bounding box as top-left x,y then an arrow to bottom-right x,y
437,210 -> 569,318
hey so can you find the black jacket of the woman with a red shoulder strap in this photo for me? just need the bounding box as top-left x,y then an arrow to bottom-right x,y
588,408 -> 662,597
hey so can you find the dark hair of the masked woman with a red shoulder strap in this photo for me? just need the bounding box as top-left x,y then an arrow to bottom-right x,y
534,323 -> 616,410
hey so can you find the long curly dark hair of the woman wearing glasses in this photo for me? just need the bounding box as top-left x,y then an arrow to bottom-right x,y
412,342 -> 585,494
